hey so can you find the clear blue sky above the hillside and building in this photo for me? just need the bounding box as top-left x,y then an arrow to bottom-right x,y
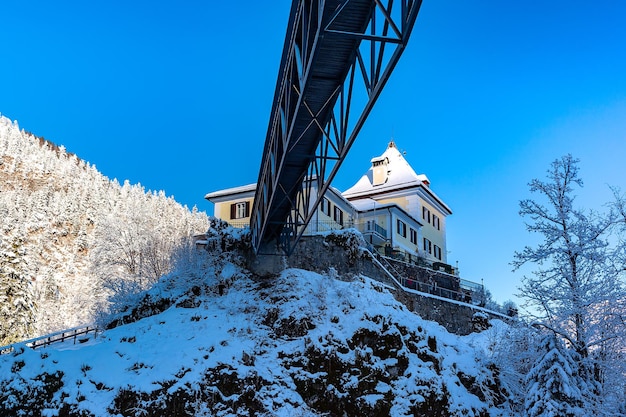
0,0 -> 626,301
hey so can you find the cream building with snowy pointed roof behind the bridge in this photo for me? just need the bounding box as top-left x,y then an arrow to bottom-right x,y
205,141 -> 452,265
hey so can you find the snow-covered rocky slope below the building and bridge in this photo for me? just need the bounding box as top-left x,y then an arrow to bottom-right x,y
0,228 -> 507,416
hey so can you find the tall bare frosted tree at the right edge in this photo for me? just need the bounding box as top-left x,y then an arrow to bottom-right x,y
513,155 -> 626,412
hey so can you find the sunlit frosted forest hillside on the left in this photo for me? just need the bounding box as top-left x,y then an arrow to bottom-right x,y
0,116 -> 208,345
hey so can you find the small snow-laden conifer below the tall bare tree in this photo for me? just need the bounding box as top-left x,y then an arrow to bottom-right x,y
524,332 -> 592,417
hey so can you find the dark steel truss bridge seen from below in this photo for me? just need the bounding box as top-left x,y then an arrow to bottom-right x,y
250,0 -> 421,255
